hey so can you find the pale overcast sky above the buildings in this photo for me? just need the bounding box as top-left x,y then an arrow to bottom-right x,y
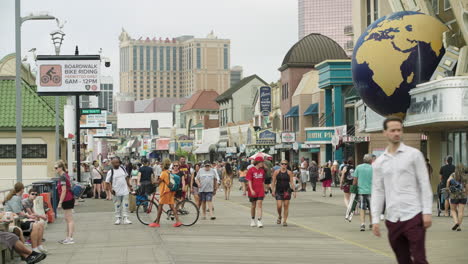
0,0 -> 298,93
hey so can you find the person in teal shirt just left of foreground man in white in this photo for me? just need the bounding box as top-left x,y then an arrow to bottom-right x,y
351,154 -> 372,231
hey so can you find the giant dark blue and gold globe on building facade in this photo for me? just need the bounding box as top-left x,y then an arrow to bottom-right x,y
352,11 -> 448,117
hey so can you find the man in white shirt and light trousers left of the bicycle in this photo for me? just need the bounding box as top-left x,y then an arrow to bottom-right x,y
106,157 -> 132,225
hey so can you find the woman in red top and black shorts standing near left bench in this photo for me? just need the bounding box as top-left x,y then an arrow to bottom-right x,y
54,160 -> 75,245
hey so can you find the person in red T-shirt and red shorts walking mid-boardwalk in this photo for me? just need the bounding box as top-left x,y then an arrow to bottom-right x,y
245,157 -> 265,228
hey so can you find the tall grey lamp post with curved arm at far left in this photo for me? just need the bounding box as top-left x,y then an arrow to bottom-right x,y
15,0 -> 55,182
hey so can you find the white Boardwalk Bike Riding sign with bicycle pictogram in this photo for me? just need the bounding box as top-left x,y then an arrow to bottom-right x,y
36,57 -> 101,93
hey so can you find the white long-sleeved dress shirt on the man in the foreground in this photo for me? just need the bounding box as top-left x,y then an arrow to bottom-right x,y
371,143 -> 432,224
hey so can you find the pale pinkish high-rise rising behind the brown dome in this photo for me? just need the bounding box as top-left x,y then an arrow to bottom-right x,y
298,0 -> 353,55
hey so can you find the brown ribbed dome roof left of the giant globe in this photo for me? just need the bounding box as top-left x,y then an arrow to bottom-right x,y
279,33 -> 349,71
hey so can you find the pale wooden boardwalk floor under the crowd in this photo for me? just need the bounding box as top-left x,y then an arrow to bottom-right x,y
44,191 -> 468,264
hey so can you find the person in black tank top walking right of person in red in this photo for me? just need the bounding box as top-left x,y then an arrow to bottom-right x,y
271,160 -> 296,226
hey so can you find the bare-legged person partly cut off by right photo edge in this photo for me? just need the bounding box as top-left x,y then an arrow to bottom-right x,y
447,164 -> 468,231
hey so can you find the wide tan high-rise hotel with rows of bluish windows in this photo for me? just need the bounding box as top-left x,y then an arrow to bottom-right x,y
119,30 -> 230,100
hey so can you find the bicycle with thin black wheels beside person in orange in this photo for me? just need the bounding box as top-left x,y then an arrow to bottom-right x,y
136,193 -> 200,226
